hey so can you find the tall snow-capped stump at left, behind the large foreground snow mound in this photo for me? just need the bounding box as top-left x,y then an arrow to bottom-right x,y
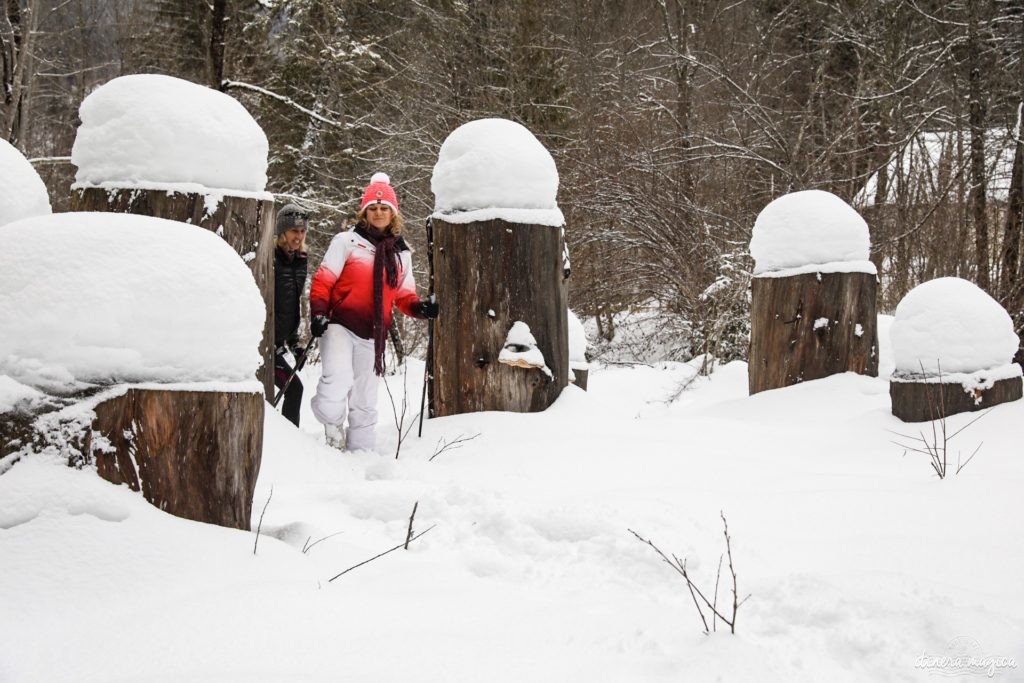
71,75 -> 274,396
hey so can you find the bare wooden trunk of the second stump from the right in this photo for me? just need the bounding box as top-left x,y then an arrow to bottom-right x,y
749,272 -> 879,394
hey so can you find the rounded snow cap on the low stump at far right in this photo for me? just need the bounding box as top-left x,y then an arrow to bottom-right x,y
890,278 -> 1020,377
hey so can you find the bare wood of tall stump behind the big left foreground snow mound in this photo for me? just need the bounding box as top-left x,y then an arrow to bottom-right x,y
71,187 -> 274,397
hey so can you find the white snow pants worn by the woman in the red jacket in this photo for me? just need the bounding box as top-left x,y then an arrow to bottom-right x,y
310,324 -> 377,451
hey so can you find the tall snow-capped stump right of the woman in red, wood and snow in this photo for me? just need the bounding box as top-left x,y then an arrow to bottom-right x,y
429,119 -> 569,417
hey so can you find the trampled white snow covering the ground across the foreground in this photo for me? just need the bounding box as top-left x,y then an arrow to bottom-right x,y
0,319 -> 1024,683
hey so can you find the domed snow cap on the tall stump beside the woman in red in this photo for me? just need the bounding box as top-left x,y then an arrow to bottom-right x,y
430,119 -> 565,226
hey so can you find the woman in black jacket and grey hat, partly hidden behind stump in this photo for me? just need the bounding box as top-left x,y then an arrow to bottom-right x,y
273,204 -> 309,427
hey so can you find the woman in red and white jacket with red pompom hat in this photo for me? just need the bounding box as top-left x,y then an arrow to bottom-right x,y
309,173 -> 437,451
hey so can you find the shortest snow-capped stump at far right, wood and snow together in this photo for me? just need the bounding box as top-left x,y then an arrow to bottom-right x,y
889,278 -> 1024,422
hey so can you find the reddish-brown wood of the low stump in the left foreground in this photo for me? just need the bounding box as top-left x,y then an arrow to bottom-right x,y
92,389 -> 264,529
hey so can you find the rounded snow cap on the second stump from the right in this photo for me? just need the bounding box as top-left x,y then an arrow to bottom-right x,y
751,189 -> 876,275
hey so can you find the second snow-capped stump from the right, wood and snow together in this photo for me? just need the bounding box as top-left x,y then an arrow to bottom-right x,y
748,190 -> 879,394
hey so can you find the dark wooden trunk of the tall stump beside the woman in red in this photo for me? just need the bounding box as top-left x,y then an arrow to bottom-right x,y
430,219 -> 569,417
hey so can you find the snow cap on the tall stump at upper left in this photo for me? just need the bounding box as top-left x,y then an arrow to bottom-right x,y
71,74 -> 269,194
